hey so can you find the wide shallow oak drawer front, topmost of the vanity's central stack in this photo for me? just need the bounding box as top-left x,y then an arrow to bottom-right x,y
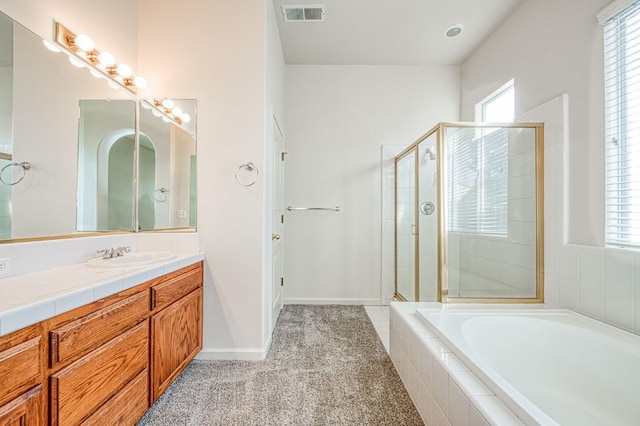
49,291 -> 149,367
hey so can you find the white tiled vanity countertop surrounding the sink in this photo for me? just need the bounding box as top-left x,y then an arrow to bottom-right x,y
0,233 -> 204,336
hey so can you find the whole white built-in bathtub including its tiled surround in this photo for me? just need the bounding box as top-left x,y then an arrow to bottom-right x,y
390,303 -> 640,426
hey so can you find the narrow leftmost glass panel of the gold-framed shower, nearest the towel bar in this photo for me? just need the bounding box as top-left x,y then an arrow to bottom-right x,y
396,150 -> 417,301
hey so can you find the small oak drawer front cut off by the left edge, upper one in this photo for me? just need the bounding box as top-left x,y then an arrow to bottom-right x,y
0,336 -> 42,404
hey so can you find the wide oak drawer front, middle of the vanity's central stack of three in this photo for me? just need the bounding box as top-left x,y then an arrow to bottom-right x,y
50,321 -> 149,425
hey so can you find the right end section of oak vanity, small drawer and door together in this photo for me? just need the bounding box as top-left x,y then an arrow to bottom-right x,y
150,263 -> 202,404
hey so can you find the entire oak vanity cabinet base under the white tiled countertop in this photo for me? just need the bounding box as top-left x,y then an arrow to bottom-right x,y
0,261 -> 203,425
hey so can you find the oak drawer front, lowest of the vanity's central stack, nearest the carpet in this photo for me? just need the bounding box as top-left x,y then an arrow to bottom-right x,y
82,369 -> 149,426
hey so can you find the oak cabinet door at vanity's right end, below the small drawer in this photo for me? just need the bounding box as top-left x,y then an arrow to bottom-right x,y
151,288 -> 202,403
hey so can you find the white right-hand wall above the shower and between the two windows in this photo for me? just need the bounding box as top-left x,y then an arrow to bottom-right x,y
461,0 -> 611,245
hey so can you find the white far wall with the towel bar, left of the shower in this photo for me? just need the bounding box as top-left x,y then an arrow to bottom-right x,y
284,65 -> 459,303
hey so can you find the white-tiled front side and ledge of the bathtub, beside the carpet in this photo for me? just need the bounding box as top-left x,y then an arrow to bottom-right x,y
389,302 -> 523,426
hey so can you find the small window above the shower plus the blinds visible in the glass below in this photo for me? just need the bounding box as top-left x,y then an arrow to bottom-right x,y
447,80 -> 514,235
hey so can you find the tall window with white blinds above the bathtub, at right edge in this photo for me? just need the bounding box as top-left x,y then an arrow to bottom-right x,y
599,2 -> 640,248
